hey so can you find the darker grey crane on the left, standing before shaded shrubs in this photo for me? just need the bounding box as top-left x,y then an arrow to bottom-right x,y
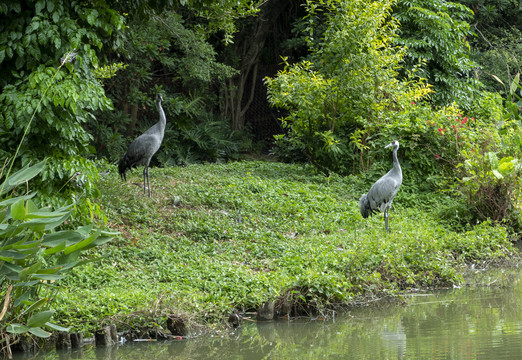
118,94 -> 167,197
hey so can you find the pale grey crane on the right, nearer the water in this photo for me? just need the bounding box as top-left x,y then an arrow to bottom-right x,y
359,140 -> 402,231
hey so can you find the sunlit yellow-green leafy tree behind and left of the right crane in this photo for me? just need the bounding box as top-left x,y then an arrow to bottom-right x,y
267,1 -> 429,173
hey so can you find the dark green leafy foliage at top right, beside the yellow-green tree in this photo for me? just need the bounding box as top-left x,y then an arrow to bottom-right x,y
393,0 -> 480,110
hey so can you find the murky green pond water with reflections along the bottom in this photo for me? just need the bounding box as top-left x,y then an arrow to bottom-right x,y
10,270 -> 522,360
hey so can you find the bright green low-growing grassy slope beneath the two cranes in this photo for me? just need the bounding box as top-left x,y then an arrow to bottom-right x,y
51,162 -> 513,329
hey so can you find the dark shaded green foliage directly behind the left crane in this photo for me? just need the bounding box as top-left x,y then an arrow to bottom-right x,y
90,13 -> 238,165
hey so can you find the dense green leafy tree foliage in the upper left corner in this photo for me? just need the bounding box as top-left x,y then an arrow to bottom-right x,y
0,0 -> 124,210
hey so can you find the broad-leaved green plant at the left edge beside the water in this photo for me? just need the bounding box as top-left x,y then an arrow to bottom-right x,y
0,162 -> 112,344
